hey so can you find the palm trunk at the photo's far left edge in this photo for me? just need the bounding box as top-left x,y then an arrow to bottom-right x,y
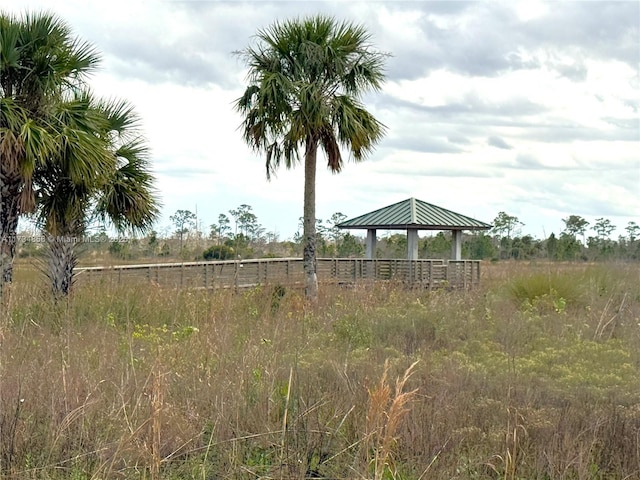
0,177 -> 21,291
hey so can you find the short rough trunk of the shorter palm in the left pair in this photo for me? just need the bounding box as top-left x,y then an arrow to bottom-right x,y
47,227 -> 78,298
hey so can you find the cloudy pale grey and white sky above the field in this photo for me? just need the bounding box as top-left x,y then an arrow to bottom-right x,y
5,0 -> 640,240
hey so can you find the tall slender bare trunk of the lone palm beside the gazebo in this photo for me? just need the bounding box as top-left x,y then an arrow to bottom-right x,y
302,137 -> 318,301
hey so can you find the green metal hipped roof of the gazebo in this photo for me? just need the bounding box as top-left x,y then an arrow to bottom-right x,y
336,198 -> 492,230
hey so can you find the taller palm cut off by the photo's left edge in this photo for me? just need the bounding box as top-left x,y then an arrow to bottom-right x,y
0,13 -> 99,289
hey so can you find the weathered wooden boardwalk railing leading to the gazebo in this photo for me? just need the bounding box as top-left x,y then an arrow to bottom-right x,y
75,258 -> 480,288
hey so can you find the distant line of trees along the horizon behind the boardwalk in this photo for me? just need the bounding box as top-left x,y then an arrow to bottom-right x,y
19,204 -> 640,261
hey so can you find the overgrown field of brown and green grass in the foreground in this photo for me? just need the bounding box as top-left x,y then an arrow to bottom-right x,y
0,263 -> 640,480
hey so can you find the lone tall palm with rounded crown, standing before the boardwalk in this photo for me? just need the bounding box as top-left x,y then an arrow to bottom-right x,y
235,15 -> 387,299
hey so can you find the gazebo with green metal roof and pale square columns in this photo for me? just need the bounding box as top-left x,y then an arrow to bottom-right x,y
336,197 -> 492,260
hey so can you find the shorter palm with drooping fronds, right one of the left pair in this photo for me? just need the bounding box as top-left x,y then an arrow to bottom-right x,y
36,93 -> 159,297
